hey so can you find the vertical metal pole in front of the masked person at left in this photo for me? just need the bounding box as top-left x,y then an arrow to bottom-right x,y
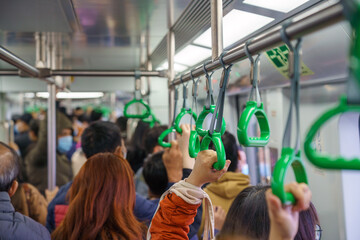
47,83 -> 56,190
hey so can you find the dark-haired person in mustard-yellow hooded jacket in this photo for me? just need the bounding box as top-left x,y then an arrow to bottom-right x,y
198,132 -> 250,237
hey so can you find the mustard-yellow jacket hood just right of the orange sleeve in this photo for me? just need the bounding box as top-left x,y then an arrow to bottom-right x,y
205,172 -> 250,199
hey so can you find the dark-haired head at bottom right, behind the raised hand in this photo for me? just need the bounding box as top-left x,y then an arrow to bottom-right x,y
218,185 -> 319,240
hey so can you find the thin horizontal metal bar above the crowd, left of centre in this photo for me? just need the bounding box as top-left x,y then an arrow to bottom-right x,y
50,70 -> 165,77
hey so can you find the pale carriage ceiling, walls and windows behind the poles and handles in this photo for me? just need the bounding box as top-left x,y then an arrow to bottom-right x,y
0,0 -> 360,239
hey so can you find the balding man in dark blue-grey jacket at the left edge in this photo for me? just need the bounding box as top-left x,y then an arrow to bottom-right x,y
0,142 -> 50,240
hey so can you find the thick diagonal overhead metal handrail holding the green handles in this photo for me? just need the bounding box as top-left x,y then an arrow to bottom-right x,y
174,3 -> 344,85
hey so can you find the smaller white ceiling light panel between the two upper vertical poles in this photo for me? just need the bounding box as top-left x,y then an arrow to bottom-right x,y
175,45 -> 211,66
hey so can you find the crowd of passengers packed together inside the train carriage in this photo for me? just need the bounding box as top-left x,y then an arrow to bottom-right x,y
0,106 -> 321,240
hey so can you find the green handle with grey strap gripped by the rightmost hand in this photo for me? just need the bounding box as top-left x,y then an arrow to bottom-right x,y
271,24 -> 308,204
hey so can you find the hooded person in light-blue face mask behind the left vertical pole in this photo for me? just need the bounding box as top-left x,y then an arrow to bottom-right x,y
25,111 -> 72,194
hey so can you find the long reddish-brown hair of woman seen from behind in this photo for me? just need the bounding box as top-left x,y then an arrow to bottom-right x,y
52,153 -> 145,240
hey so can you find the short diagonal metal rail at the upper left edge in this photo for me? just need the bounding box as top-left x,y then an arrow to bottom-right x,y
0,46 -> 40,77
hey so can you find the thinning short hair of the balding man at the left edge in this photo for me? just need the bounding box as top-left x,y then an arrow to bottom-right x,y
0,142 -> 20,192
